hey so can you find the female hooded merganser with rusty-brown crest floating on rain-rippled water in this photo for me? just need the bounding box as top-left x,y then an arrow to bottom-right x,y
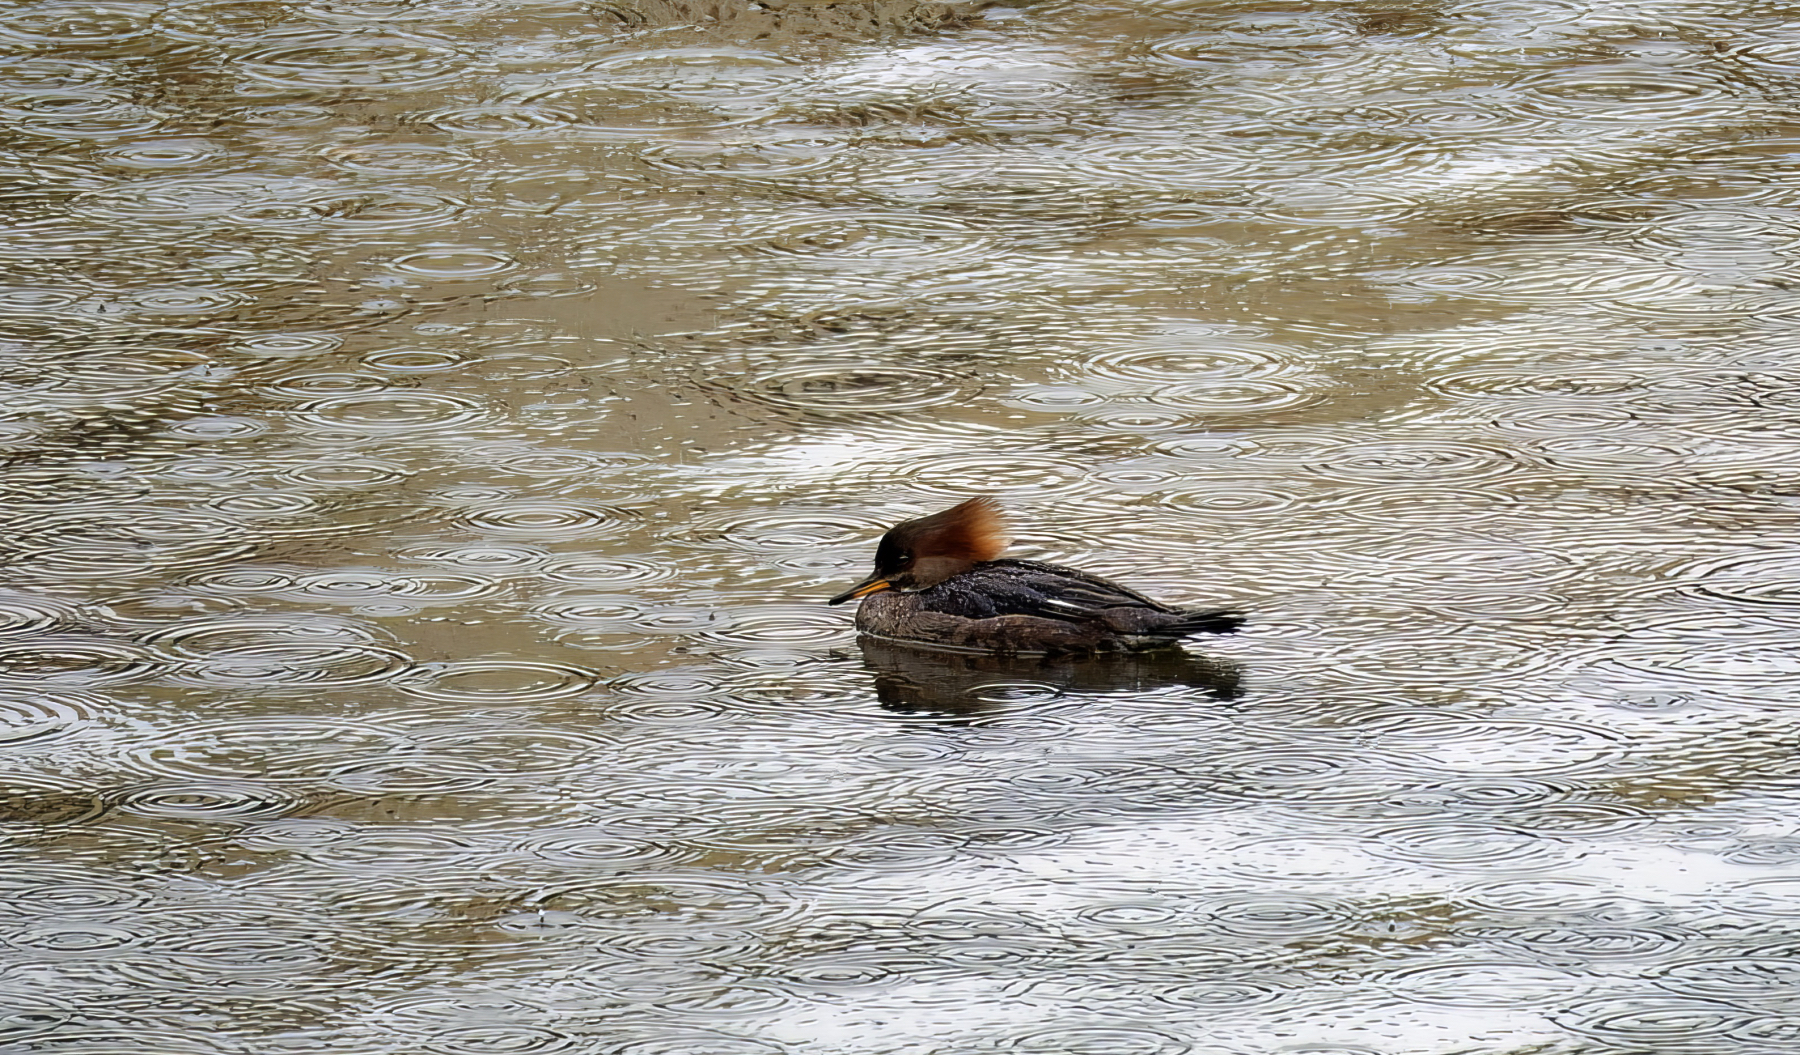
830,499 -> 1244,654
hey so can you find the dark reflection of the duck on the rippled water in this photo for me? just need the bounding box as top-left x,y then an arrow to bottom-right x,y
857,636 -> 1238,720
